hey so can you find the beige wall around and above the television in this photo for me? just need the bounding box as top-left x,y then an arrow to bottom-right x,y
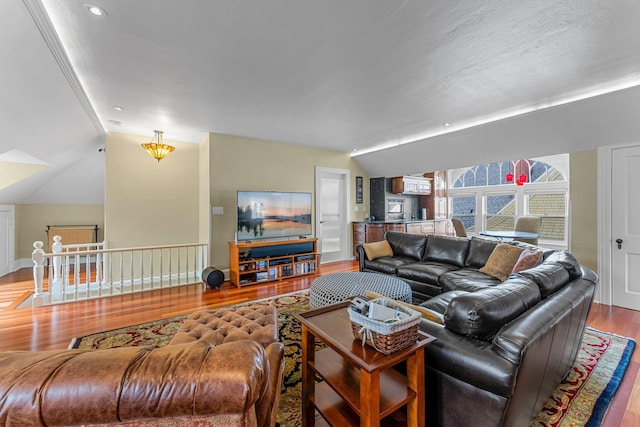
210,134 -> 369,268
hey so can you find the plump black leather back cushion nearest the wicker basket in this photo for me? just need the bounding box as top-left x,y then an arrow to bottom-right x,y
444,275 -> 540,340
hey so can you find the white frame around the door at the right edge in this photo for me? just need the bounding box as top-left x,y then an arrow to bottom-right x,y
595,142 -> 640,306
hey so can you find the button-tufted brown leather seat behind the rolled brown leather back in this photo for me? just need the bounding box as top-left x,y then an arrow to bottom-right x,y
169,305 -> 278,347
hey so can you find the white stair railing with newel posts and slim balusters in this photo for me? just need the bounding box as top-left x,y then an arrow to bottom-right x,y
32,236 -> 208,306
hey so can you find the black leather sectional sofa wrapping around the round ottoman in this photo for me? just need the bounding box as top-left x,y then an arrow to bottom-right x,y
356,232 -> 598,427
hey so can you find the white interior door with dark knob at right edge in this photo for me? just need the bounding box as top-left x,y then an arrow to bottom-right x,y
611,147 -> 640,310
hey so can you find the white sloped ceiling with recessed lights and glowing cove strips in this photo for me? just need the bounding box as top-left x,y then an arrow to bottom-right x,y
0,0 -> 640,203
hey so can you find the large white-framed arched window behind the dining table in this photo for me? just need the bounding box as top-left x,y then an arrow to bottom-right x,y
448,154 -> 569,247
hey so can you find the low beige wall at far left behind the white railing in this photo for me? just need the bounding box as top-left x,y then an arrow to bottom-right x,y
15,204 -> 104,260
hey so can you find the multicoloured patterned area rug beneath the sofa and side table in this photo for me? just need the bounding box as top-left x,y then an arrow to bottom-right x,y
70,291 -> 635,427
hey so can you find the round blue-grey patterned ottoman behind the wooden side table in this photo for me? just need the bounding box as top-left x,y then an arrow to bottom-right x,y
309,272 -> 411,308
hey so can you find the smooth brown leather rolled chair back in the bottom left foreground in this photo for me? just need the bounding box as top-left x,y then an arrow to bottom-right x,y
0,340 -> 284,427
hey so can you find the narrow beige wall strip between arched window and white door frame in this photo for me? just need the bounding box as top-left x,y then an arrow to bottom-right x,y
569,150 -> 598,272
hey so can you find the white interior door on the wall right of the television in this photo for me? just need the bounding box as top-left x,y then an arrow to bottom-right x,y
316,168 -> 349,262
